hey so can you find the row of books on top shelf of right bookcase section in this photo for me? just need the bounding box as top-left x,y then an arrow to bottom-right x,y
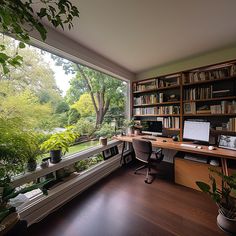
183,64 -> 236,83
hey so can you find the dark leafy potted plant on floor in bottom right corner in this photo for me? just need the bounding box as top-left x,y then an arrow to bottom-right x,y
196,168 -> 236,235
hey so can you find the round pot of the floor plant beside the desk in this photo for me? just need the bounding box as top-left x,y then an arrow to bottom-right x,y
217,212 -> 236,235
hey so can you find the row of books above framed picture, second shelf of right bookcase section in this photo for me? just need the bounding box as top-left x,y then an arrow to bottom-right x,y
184,85 -> 213,100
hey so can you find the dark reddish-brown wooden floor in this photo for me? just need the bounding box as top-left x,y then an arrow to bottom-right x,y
28,163 -> 224,236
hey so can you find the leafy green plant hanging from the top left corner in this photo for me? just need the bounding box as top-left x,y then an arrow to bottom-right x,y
0,0 -> 79,74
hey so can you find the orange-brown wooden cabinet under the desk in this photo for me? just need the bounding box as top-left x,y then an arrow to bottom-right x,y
174,157 -> 221,190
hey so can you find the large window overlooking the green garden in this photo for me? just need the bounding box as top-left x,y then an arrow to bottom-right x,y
0,36 -> 128,176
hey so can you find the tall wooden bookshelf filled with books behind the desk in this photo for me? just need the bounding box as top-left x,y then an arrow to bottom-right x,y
131,60 -> 236,140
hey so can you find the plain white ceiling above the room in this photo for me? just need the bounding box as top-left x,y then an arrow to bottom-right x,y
45,0 -> 236,73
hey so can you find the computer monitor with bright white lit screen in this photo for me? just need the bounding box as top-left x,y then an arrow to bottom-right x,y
183,121 -> 210,142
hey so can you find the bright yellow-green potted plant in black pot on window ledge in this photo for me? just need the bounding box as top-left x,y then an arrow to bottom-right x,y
40,131 -> 76,164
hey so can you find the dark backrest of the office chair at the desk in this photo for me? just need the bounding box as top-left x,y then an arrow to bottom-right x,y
132,139 -> 152,163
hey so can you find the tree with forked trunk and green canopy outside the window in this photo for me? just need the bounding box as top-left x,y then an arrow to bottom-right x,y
53,56 -> 126,127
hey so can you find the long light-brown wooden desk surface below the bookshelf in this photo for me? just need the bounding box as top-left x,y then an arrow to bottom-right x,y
114,135 -> 236,160
